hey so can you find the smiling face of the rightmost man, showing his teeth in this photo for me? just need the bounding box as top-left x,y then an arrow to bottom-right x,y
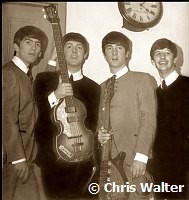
152,48 -> 176,74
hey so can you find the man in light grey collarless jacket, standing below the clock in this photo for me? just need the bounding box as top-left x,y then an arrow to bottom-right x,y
98,31 -> 156,200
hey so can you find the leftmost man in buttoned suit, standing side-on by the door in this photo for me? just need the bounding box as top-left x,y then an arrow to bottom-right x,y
2,26 -> 48,200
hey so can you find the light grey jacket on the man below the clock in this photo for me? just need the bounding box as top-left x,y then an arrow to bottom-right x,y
98,71 -> 157,165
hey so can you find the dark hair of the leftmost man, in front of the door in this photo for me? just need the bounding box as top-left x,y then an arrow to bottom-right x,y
14,26 -> 48,58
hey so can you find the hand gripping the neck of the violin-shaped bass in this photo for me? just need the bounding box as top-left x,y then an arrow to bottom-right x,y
54,76 -> 73,99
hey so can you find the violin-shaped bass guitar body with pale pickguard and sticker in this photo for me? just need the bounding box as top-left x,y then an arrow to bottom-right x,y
53,98 -> 93,162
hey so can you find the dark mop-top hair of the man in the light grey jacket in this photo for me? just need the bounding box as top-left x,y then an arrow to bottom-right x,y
102,31 -> 132,54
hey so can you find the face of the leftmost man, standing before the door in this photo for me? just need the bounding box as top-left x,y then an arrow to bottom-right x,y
14,37 -> 41,66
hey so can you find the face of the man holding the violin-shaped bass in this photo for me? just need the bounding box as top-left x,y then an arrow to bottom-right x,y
64,41 -> 87,71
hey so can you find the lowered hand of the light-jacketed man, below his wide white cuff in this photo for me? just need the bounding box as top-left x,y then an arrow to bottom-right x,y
131,160 -> 146,178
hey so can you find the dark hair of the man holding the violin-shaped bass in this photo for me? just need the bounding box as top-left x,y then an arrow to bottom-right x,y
62,32 -> 89,57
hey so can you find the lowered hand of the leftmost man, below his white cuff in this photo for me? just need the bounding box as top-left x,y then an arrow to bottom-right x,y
14,161 -> 29,183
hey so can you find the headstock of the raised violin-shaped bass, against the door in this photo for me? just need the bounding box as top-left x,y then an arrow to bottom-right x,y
44,4 -> 59,23
